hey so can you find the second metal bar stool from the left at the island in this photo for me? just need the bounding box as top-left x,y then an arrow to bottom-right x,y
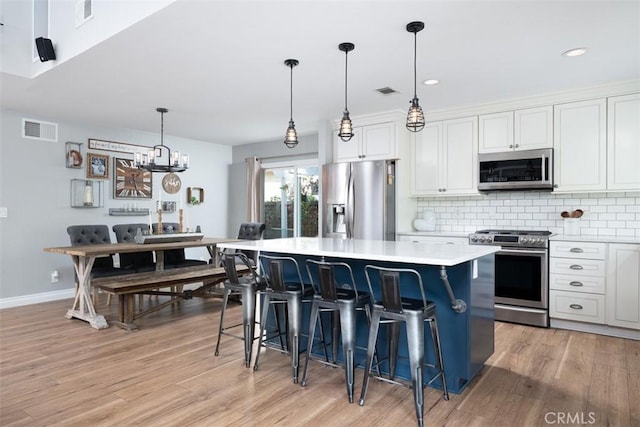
253,254 -> 326,384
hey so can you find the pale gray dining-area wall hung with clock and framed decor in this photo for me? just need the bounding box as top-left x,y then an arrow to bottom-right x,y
0,110 -> 230,307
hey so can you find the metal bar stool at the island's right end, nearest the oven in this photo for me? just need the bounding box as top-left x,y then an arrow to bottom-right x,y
359,265 -> 449,426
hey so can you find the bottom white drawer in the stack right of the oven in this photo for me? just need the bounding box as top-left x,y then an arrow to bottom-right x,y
549,290 -> 604,324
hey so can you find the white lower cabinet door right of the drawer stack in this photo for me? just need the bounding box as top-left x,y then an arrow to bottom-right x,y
607,243 -> 640,329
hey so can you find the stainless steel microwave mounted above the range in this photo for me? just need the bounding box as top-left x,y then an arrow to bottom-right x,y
478,148 -> 553,191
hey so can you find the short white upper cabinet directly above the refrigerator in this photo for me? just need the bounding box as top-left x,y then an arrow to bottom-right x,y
333,122 -> 398,162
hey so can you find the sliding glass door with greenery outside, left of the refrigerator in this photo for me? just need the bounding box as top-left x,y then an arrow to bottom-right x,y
263,162 -> 319,239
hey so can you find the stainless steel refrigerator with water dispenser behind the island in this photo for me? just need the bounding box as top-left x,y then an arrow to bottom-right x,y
322,160 -> 396,240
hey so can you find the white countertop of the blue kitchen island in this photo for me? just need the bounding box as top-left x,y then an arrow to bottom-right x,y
218,237 -> 500,267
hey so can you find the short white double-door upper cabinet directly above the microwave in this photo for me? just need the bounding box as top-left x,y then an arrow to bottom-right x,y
478,106 -> 553,153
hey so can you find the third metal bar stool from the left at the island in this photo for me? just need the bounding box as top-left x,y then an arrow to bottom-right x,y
301,259 -> 378,403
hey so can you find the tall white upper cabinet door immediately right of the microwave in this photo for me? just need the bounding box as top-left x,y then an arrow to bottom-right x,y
553,99 -> 607,192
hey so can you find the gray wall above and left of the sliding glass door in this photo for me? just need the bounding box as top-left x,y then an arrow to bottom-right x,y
227,133 -> 318,236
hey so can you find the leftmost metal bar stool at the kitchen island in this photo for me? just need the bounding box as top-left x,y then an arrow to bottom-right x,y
215,252 -> 266,368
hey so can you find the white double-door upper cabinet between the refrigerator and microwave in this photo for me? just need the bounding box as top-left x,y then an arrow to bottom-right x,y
410,117 -> 478,196
